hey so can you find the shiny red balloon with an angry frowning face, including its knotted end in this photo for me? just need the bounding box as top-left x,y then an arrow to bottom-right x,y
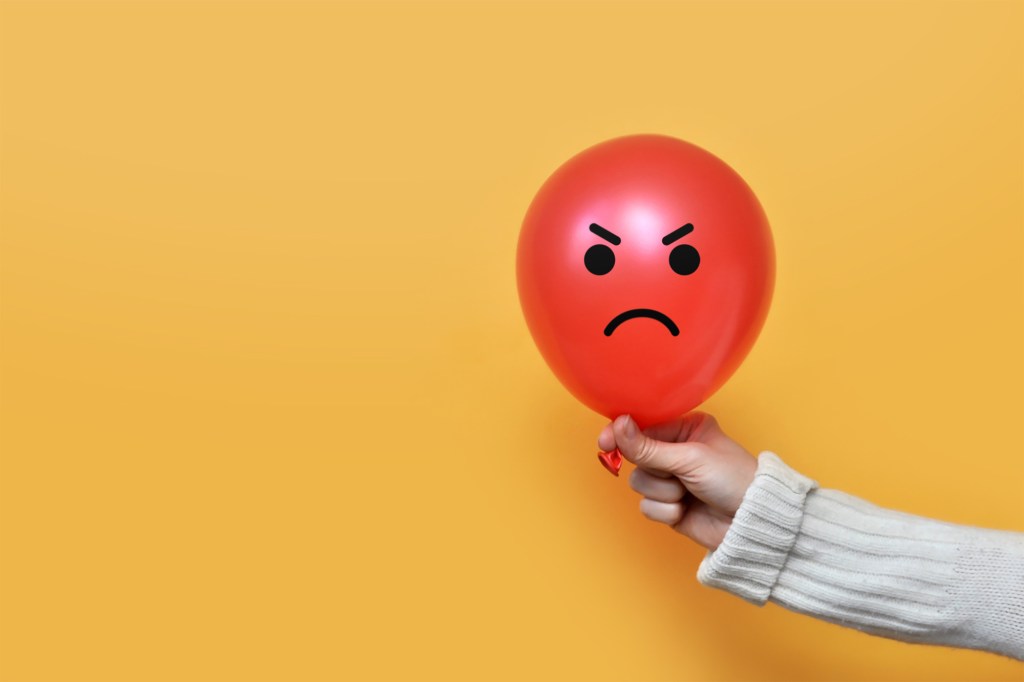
516,135 -> 775,475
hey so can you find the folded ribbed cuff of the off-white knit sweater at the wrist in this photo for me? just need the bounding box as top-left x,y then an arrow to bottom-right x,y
697,452 -> 817,605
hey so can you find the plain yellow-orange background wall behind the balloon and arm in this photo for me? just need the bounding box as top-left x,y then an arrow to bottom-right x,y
0,1 -> 1024,681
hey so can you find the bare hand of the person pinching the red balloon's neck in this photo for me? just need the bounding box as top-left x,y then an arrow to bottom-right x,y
597,412 -> 758,550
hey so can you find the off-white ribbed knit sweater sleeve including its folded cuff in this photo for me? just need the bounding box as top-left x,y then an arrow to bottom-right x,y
697,453 -> 1024,659
